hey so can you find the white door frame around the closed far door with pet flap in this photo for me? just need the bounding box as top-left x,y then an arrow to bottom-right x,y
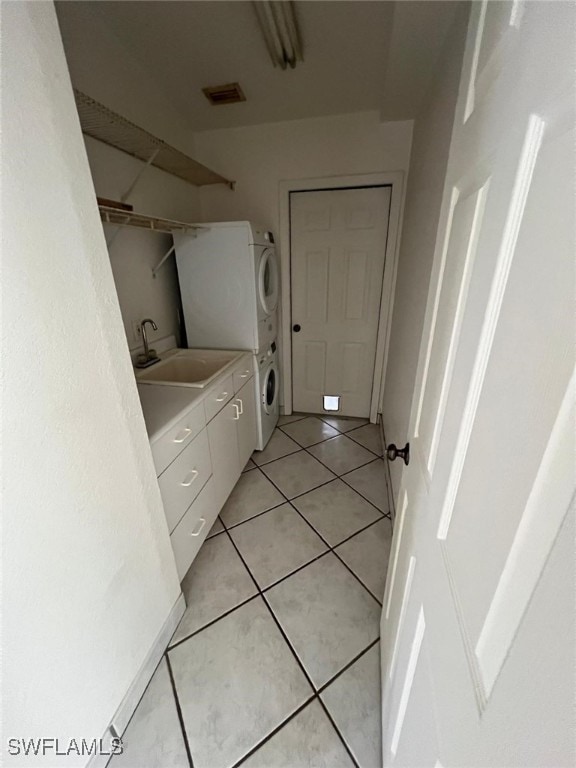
279,171 -> 405,424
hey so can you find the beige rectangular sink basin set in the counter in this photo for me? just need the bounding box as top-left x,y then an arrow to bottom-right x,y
136,349 -> 246,389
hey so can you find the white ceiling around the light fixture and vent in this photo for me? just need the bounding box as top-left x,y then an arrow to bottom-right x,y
58,0 -> 457,131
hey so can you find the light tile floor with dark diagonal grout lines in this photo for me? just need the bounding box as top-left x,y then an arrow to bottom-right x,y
109,414 -> 392,768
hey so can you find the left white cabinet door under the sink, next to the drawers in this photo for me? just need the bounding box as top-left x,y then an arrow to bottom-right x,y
207,401 -> 245,507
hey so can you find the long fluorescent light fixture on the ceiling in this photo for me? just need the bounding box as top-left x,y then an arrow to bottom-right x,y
252,0 -> 304,69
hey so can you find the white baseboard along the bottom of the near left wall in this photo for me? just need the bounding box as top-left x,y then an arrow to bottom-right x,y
86,592 -> 186,768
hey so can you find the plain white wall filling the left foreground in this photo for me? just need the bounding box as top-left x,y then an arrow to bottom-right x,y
2,3 -> 180,766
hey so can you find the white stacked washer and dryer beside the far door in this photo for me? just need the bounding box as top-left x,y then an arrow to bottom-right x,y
174,221 -> 280,450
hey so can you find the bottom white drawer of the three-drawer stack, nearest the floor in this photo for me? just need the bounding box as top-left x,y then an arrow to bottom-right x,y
170,478 -> 219,581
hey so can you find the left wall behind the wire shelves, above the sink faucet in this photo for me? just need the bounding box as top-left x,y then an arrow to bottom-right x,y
85,137 -> 200,349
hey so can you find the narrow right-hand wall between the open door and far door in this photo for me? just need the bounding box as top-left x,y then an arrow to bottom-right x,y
382,3 -> 468,499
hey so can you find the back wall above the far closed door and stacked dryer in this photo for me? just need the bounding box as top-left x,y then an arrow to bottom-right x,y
195,112 -> 412,234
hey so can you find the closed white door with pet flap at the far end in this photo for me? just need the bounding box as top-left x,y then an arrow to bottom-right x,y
290,187 -> 391,417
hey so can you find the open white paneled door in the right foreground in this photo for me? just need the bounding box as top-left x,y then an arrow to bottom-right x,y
382,0 -> 576,768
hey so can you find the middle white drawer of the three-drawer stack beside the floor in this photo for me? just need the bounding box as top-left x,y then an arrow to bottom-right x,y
158,429 -> 212,531
